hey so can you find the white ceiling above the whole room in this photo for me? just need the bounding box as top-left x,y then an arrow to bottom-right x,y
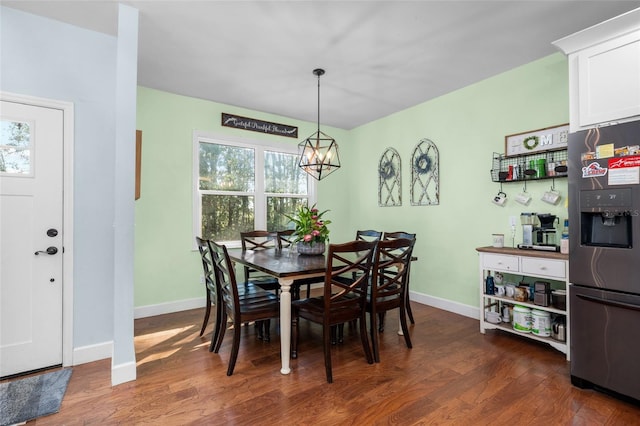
5,0 -> 640,129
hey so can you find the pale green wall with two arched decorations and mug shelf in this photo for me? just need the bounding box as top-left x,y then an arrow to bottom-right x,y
330,53 -> 569,307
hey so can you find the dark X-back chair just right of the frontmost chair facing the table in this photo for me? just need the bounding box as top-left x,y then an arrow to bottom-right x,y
366,238 -> 415,362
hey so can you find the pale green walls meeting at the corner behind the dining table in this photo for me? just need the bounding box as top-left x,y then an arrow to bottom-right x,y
135,53 -> 569,308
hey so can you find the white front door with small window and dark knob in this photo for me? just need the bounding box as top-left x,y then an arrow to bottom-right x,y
0,100 -> 64,377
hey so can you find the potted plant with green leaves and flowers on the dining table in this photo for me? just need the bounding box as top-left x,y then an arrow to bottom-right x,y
286,204 -> 331,254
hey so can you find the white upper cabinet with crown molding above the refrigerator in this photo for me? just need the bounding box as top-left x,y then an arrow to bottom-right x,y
553,9 -> 640,132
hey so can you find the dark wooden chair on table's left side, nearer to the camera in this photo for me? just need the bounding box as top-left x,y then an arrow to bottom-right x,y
209,241 -> 280,376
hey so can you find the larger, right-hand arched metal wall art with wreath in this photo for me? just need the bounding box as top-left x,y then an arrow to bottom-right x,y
411,139 -> 440,206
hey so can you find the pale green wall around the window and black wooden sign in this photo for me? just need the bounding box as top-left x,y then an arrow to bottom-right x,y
134,87 -> 347,308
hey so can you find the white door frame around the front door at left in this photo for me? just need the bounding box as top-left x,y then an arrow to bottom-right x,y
0,91 -> 74,367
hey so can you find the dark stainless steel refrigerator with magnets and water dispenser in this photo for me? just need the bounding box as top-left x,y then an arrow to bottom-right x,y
568,121 -> 640,402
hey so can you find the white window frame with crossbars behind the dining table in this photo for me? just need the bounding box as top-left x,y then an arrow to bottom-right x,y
191,131 -> 317,250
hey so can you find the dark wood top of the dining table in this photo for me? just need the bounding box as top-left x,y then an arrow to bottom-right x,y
228,248 -> 326,278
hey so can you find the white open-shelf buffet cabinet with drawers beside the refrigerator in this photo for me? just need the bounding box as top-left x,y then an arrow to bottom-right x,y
476,247 -> 571,361
